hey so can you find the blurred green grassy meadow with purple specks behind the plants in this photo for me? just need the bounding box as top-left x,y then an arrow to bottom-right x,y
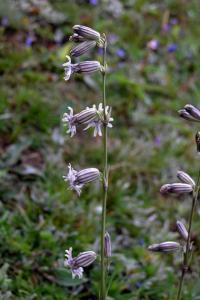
0,0 -> 200,300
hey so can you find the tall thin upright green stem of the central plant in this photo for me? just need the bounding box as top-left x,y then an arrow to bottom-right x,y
100,37 -> 108,300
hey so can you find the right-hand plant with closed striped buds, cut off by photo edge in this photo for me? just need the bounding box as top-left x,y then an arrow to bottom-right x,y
148,104 -> 200,300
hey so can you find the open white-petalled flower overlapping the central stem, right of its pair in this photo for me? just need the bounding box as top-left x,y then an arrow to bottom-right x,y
84,103 -> 113,137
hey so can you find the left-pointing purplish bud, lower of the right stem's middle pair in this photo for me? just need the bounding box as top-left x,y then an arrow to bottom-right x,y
160,183 -> 193,194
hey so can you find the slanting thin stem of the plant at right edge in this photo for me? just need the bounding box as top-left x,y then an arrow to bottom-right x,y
177,170 -> 200,300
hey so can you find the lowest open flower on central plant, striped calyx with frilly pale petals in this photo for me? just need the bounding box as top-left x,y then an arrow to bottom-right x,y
64,247 -> 96,279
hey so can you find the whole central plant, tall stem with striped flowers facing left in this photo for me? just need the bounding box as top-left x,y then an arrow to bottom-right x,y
62,25 -> 113,300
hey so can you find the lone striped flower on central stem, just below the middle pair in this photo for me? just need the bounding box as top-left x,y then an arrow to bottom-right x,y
63,164 -> 100,196
